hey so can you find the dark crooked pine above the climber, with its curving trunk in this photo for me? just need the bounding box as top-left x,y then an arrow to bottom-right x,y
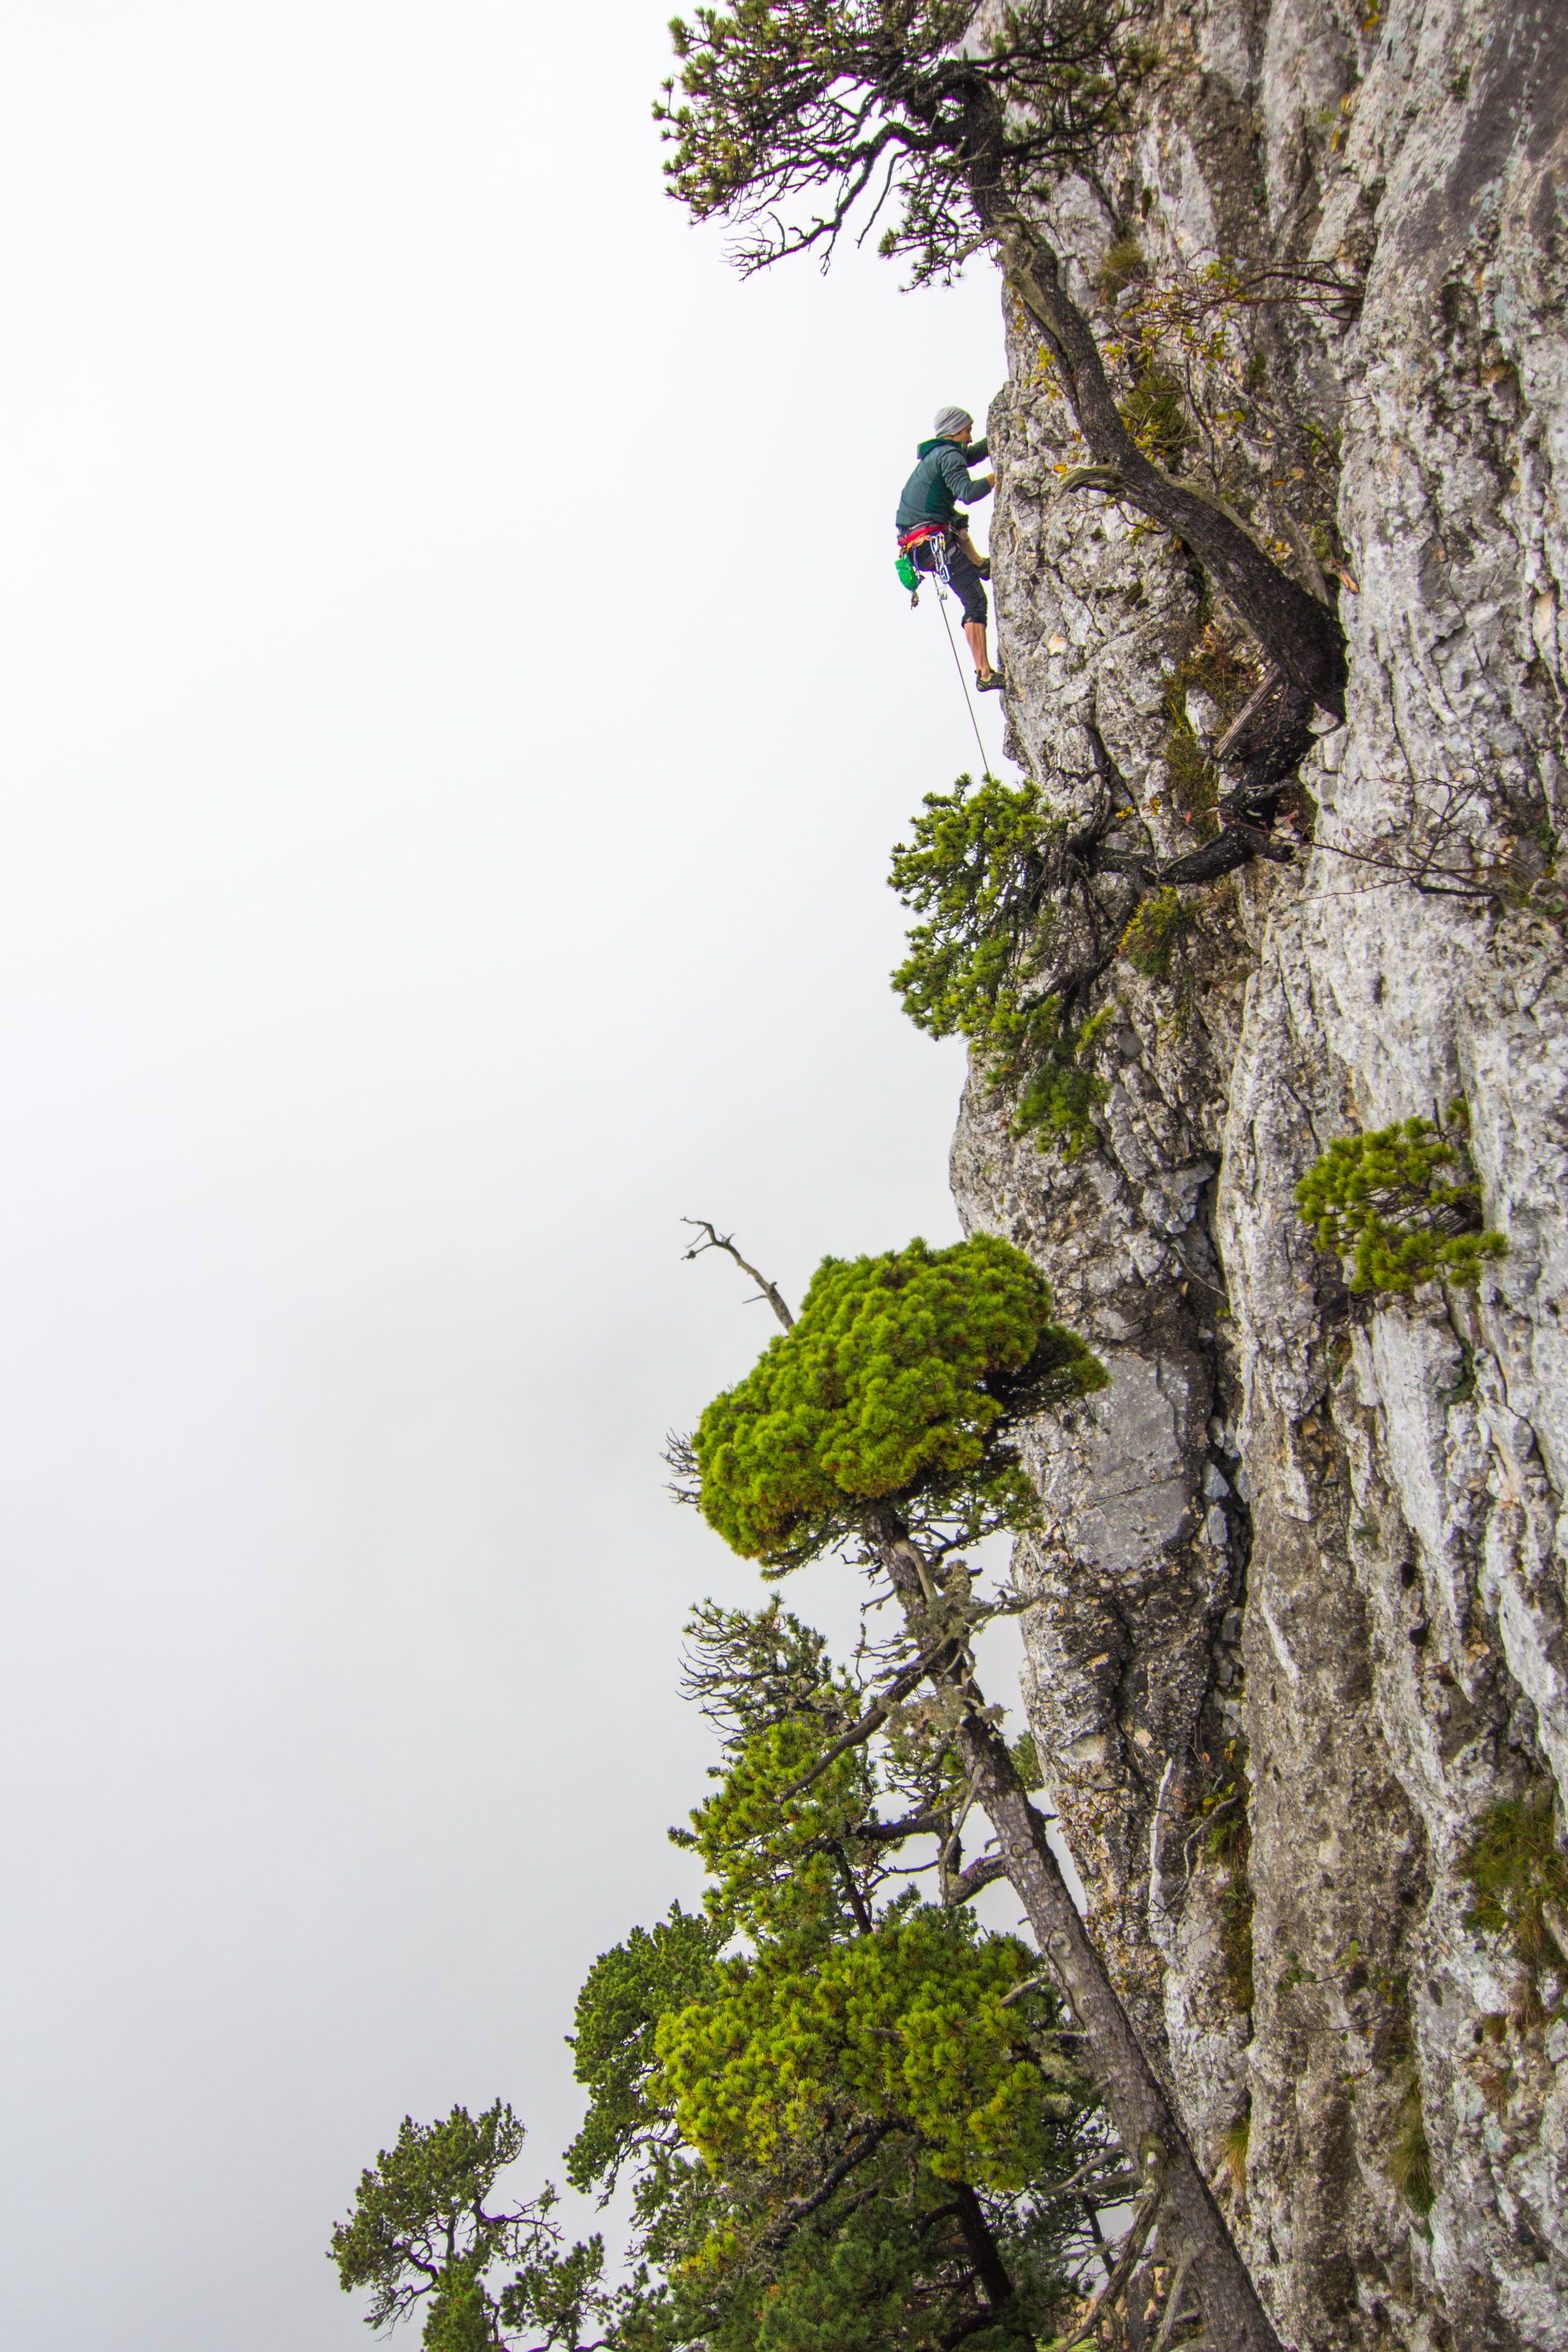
654,0 -> 1345,717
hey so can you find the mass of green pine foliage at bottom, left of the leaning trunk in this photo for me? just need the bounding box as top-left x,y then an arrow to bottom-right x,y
332,1602 -> 1128,2352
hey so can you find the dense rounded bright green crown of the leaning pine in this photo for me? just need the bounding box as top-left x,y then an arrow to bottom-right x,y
691,1235 -> 1107,1571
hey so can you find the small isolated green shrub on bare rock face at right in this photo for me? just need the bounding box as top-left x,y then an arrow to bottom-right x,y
1295,1110 -> 1509,1296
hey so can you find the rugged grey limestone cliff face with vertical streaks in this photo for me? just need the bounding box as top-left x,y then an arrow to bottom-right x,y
952,0 -> 1568,2352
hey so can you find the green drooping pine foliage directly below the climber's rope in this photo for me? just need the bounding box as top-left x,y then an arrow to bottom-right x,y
888,776 -> 1109,1155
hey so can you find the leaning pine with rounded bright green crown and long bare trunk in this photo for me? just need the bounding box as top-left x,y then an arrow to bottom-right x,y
677,1225 -> 1279,2352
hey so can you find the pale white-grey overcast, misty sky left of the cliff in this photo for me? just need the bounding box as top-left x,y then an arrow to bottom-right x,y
0,0 -> 1020,2352
